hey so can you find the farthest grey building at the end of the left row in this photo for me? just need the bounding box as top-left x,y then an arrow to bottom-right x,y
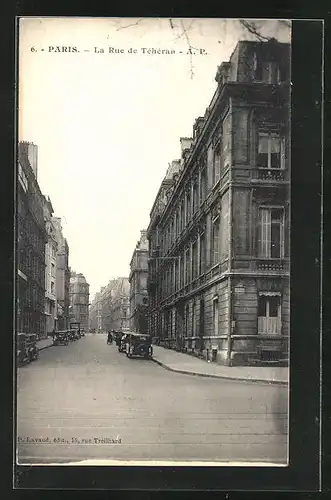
69,271 -> 90,331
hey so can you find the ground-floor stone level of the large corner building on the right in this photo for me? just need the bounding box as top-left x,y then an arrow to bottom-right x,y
150,275 -> 290,365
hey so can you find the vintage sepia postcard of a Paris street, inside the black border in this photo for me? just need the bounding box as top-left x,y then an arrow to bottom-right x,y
15,17 -> 292,468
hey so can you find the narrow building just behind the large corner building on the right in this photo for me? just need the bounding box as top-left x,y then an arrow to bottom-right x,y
129,230 -> 148,333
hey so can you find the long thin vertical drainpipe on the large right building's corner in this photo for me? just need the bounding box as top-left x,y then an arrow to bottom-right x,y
227,97 -> 233,366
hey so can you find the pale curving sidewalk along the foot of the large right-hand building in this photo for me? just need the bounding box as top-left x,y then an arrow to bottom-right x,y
153,345 -> 289,385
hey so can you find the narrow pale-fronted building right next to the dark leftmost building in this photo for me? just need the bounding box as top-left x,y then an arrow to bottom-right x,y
43,196 -> 58,336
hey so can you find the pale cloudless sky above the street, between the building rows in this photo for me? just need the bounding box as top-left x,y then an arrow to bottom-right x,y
18,17 -> 290,298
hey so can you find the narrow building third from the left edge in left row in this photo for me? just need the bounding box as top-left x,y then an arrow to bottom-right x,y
52,217 -> 70,330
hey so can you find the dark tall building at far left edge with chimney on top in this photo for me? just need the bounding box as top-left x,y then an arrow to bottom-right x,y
16,142 -> 47,338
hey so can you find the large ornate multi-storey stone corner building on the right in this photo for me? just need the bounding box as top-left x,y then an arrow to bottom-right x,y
148,39 -> 290,365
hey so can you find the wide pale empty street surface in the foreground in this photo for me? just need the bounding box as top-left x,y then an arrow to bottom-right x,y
17,335 -> 287,464
